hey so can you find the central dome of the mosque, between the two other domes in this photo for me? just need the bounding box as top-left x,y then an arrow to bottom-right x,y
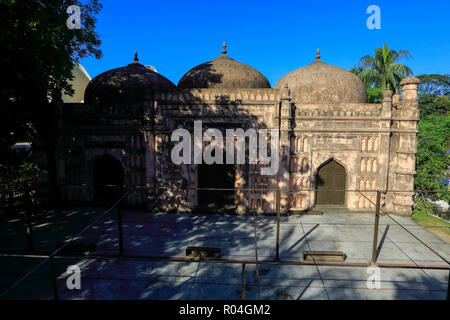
178,43 -> 270,89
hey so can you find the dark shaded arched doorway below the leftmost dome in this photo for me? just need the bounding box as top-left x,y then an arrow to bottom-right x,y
93,154 -> 124,205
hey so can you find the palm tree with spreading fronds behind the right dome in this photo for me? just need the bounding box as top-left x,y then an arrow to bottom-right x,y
350,43 -> 412,92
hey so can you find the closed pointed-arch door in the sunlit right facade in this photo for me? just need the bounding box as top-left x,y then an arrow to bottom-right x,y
316,159 -> 347,204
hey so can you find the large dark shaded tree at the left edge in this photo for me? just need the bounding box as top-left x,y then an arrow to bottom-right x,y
0,0 -> 102,185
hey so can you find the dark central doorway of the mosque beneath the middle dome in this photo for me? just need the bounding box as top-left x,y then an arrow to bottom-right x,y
197,152 -> 236,209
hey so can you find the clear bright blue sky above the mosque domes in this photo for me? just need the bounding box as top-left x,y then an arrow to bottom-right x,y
81,0 -> 450,86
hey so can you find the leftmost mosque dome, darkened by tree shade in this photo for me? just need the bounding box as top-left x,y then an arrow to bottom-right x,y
84,53 -> 176,104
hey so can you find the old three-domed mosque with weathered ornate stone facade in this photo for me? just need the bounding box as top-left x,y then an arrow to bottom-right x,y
34,44 -> 419,216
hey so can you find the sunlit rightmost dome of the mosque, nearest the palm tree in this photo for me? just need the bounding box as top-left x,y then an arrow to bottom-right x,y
275,50 -> 367,104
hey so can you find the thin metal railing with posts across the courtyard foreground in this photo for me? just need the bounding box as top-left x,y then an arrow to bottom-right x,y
0,186 -> 450,299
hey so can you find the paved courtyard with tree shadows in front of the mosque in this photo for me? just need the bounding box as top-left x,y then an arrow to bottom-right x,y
0,209 -> 450,299
